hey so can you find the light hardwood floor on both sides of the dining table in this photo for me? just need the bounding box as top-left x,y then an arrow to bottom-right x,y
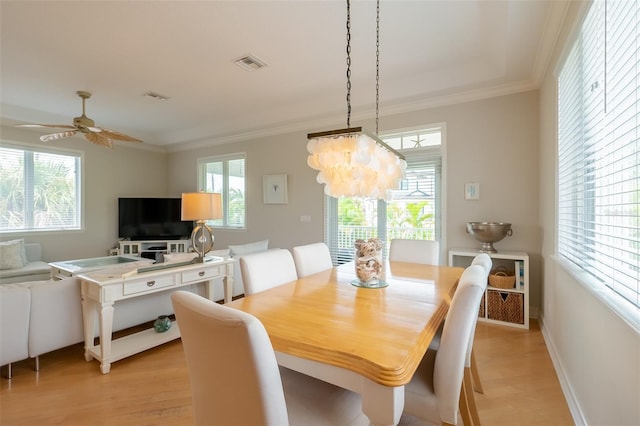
0,321 -> 574,426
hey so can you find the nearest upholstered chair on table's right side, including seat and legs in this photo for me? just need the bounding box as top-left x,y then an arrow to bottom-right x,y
404,265 -> 487,425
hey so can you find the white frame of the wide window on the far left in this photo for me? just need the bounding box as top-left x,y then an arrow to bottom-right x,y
0,140 -> 85,236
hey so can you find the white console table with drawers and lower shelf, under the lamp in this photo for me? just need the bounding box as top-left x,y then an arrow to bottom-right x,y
79,258 -> 234,374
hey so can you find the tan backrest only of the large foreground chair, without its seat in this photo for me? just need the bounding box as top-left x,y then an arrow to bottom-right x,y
171,291 -> 289,425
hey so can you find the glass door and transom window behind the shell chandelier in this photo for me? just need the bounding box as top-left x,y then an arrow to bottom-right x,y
325,127 -> 442,264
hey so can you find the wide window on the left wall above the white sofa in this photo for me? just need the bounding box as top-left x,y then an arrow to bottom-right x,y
0,145 -> 82,233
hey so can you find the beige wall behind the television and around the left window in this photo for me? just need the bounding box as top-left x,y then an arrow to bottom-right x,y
0,127 -> 169,262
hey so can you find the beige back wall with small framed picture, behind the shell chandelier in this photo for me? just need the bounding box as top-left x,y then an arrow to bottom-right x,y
168,91 -> 541,313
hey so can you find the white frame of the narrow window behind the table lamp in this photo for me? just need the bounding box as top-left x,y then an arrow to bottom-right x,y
197,152 -> 247,230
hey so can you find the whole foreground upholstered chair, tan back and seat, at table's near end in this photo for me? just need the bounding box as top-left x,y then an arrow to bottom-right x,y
171,291 -> 368,426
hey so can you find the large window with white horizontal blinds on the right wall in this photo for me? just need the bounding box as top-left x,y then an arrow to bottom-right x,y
557,0 -> 640,308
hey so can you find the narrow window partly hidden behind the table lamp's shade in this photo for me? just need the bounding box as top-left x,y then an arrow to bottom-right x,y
198,154 -> 246,229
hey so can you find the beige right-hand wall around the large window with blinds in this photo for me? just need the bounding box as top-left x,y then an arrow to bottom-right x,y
539,3 -> 640,426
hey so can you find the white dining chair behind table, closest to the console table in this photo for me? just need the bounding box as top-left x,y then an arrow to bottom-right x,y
240,249 -> 298,296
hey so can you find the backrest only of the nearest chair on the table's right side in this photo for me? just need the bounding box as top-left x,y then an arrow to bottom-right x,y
433,265 -> 487,425
